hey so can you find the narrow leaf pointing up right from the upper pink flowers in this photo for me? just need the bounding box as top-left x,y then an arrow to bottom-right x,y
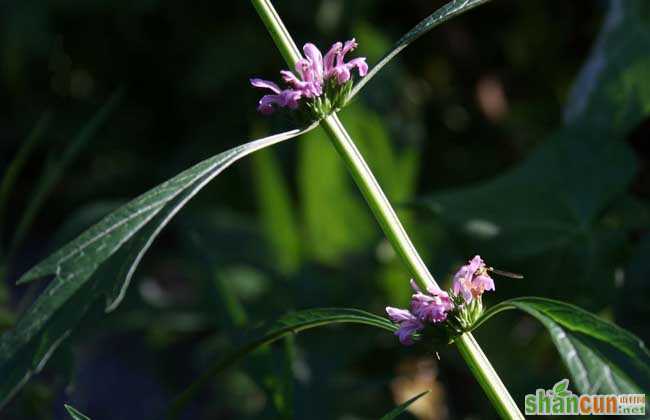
348,0 -> 489,101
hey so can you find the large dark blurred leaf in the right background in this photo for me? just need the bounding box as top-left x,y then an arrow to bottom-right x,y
421,0 -> 650,307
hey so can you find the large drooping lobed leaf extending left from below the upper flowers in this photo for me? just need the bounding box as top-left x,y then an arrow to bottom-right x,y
0,124 -> 316,406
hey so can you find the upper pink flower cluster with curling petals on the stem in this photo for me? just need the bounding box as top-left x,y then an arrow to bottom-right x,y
250,39 -> 368,115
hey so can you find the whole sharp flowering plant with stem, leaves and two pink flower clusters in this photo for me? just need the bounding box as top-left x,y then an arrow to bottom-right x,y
0,0 -> 650,419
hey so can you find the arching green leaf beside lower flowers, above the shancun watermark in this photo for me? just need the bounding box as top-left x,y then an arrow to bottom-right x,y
475,297 -> 650,394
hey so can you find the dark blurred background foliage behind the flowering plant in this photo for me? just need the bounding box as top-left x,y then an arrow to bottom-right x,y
0,0 -> 650,420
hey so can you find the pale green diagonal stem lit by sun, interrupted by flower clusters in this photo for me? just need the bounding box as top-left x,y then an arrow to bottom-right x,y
251,0 -> 524,419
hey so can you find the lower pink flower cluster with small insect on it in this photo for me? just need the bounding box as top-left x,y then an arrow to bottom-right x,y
386,255 -> 494,345
